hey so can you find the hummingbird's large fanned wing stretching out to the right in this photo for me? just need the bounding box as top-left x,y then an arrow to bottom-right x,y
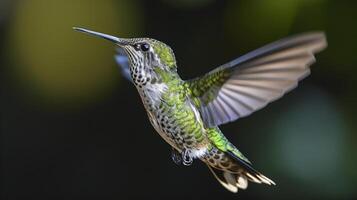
187,32 -> 327,127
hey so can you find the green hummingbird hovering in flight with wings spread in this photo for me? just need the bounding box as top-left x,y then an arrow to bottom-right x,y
74,27 -> 327,192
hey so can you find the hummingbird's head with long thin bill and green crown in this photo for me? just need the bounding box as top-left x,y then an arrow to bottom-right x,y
73,27 -> 176,81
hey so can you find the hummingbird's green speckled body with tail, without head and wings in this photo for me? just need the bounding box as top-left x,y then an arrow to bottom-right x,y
133,63 -> 268,191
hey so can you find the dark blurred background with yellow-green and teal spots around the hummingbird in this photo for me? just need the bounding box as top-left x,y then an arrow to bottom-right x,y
0,0 -> 357,199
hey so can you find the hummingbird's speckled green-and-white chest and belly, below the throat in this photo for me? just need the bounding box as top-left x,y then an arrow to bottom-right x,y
139,79 -> 209,158
